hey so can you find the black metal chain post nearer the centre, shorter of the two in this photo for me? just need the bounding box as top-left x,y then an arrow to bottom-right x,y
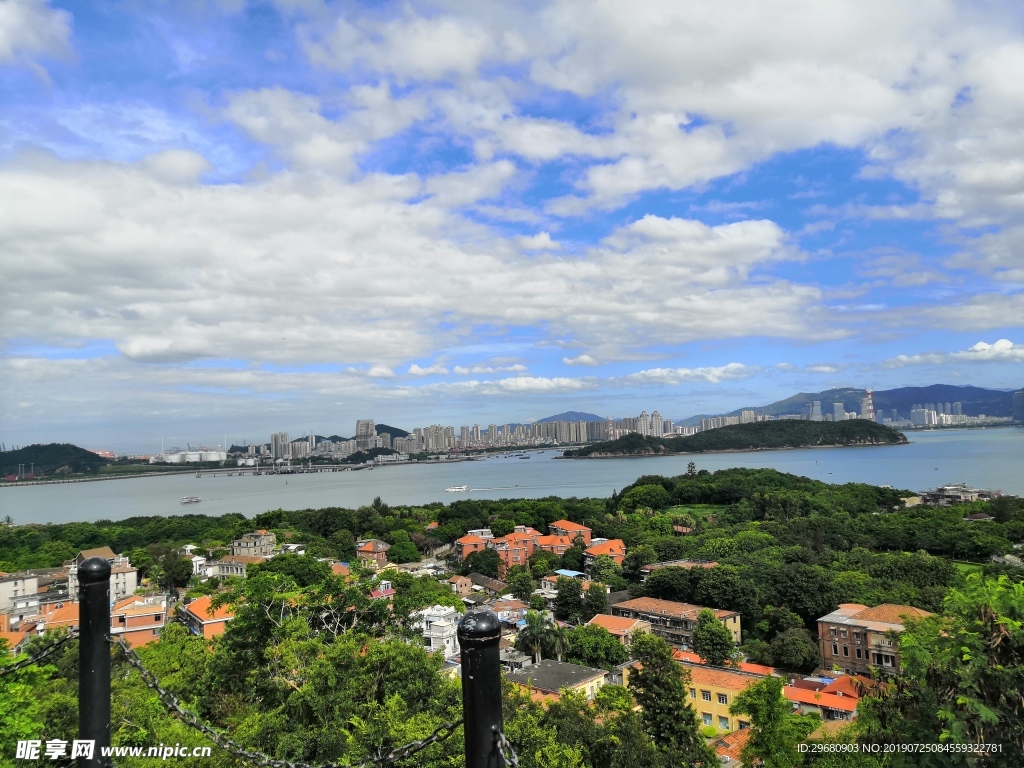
459,610 -> 505,768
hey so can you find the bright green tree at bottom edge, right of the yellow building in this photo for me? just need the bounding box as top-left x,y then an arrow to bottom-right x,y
729,677 -> 821,768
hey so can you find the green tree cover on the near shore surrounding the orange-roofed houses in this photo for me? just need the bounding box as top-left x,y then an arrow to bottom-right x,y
0,469 -> 1024,768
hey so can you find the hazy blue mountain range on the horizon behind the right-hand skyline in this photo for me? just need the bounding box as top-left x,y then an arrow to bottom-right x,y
676,384 -> 1014,426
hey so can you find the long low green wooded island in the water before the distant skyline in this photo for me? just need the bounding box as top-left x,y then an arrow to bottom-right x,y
563,419 -> 907,459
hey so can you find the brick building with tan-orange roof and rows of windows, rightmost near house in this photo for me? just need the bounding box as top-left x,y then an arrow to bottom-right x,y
818,603 -> 931,675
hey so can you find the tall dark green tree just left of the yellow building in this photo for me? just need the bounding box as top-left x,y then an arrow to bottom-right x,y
629,633 -> 717,766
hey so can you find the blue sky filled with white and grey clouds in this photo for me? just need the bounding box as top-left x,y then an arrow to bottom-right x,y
0,0 -> 1024,451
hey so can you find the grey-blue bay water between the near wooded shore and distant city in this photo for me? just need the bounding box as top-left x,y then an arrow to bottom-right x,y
0,427 -> 1024,524
